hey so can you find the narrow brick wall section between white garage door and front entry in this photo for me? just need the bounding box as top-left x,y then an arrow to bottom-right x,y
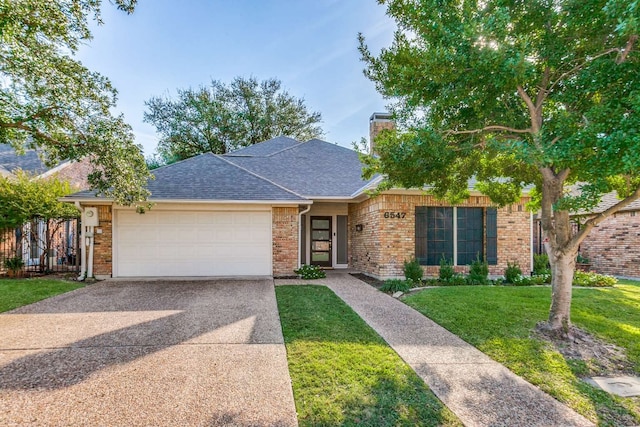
272,207 -> 298,276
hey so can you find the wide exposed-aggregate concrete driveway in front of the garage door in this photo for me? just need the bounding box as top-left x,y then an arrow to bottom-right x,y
0,280 -> 297,426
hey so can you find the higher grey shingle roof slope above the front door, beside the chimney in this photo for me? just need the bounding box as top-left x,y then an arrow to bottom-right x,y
224,139 -> 371,198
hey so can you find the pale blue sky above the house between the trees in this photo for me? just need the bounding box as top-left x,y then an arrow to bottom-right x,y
78,0 -> 395,155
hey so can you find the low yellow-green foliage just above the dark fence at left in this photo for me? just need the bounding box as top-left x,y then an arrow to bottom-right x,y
0,171 -> 80,230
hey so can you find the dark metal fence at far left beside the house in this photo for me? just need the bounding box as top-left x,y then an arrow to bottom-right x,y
0,219 -> 80,275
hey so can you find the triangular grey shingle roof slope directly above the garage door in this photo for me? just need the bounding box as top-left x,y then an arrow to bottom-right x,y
71,153 -> 305,201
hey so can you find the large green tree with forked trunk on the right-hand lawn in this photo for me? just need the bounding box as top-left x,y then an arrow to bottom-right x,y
360,0 -> 640,330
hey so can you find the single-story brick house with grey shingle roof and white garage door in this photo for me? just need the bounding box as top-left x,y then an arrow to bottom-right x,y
66,113 -> 533,278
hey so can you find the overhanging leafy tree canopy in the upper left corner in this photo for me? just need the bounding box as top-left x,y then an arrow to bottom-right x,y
0,0 -> 149,205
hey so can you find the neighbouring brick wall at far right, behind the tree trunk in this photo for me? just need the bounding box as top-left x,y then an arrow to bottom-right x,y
580,211 -> 640,278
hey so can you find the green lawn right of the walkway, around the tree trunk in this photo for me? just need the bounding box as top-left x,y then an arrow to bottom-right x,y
404,281 -> 640,426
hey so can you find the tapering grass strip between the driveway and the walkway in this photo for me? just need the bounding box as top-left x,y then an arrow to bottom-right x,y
276,286 -> 461,426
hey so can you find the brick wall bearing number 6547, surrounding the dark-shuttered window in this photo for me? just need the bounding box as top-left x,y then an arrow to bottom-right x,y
349,194 -> 532,278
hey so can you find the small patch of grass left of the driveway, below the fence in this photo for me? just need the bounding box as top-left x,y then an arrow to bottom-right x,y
0,279 -> 84,313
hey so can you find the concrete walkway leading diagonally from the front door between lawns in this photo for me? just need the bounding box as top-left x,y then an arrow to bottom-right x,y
276,271 -> 593,427
